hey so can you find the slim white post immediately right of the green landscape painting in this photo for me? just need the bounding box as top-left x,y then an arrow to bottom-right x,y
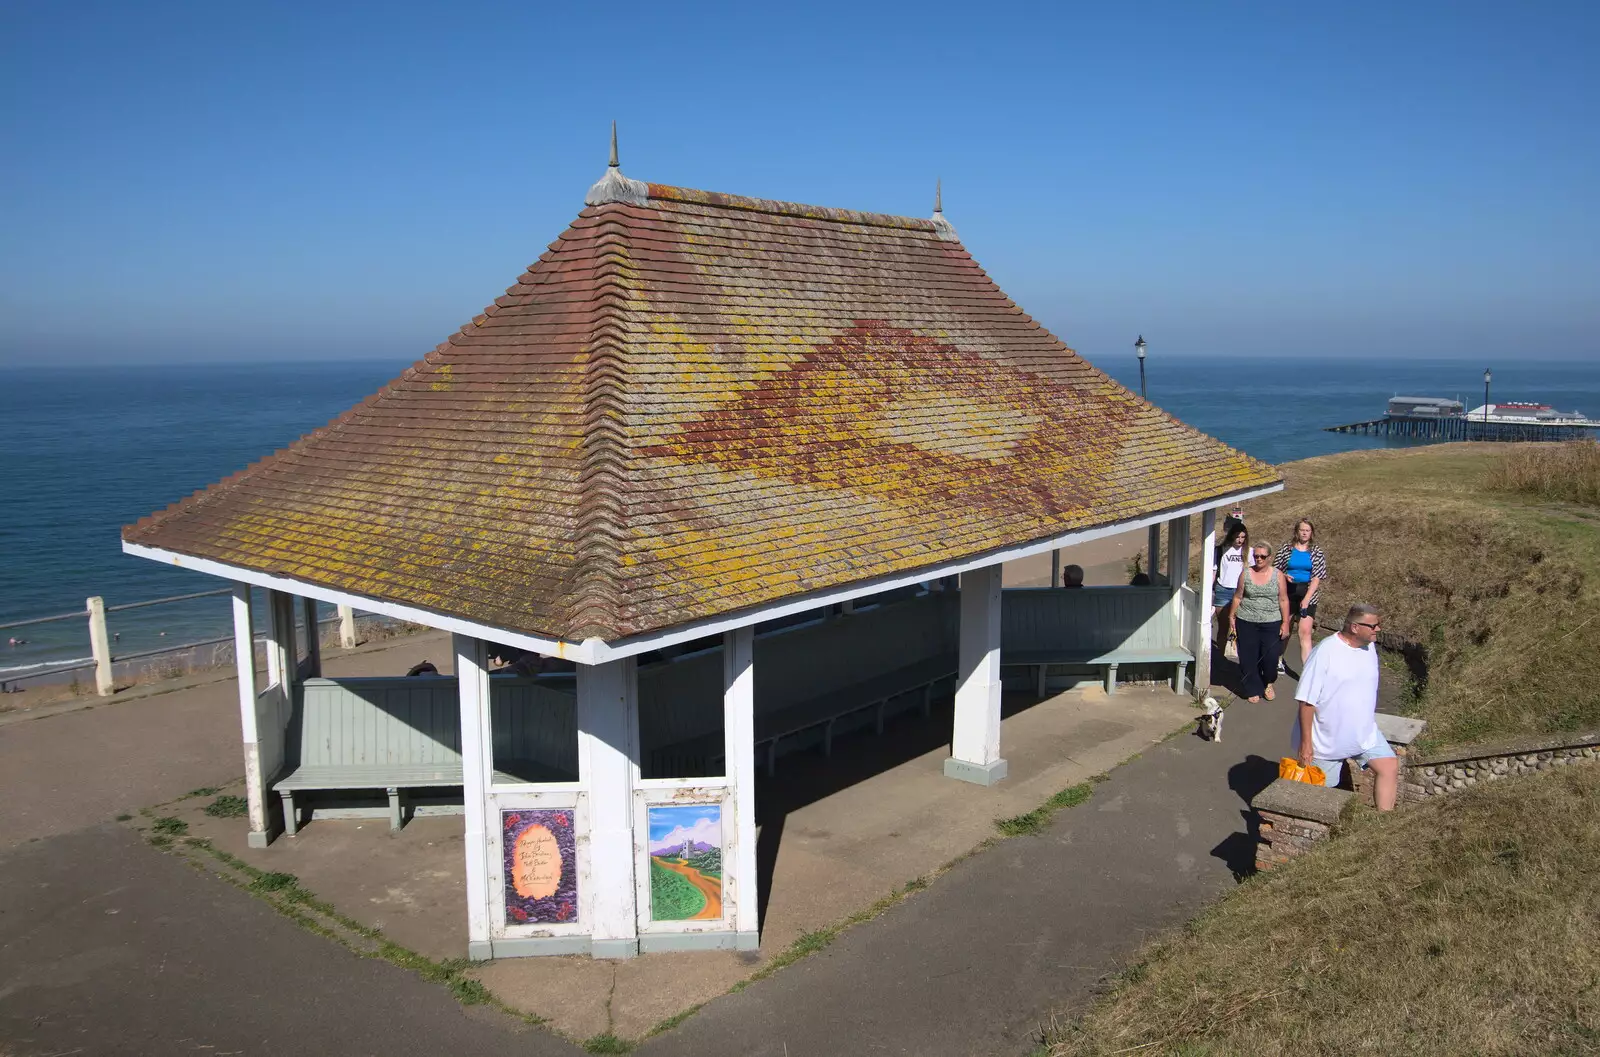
722,624 -> 762,950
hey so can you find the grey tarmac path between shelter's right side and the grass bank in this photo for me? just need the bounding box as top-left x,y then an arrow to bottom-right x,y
638,678 -> 1293,1057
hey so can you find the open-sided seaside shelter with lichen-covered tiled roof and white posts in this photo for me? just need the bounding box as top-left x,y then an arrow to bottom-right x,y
123,141 -> 1282,958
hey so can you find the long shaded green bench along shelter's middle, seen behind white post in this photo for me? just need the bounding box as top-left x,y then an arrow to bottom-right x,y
638,593 -> 957,776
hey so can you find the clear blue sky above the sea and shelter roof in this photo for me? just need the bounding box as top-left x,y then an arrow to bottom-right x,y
0,0 -> 1600,365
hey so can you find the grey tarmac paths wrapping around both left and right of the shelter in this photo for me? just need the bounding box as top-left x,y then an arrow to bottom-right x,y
0,614 -> 1312,1057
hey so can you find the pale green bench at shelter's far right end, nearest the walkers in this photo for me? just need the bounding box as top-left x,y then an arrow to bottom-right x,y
1000,587 -> 1194,697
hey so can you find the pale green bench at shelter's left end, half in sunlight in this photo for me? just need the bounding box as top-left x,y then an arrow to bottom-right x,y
272,676 -> 578,836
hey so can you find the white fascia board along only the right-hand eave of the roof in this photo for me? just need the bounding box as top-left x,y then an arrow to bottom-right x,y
584,485 -> 1283,662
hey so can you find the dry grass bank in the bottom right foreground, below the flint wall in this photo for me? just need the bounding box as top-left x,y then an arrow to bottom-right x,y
1048,764 -> 1600,1057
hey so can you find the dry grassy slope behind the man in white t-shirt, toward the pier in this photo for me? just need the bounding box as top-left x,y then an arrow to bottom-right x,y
1216,445 -> 1600,745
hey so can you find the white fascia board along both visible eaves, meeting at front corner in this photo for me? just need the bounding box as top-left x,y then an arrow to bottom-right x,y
122,485 -> 1283,664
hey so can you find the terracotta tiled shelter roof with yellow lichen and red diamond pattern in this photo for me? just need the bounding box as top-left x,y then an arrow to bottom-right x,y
123,184 -> 1278,641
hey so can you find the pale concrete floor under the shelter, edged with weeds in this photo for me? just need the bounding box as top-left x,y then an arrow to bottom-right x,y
162,671 -> 1195,1038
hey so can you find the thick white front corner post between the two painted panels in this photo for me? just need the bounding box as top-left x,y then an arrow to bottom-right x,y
578,657 -> 638,958
